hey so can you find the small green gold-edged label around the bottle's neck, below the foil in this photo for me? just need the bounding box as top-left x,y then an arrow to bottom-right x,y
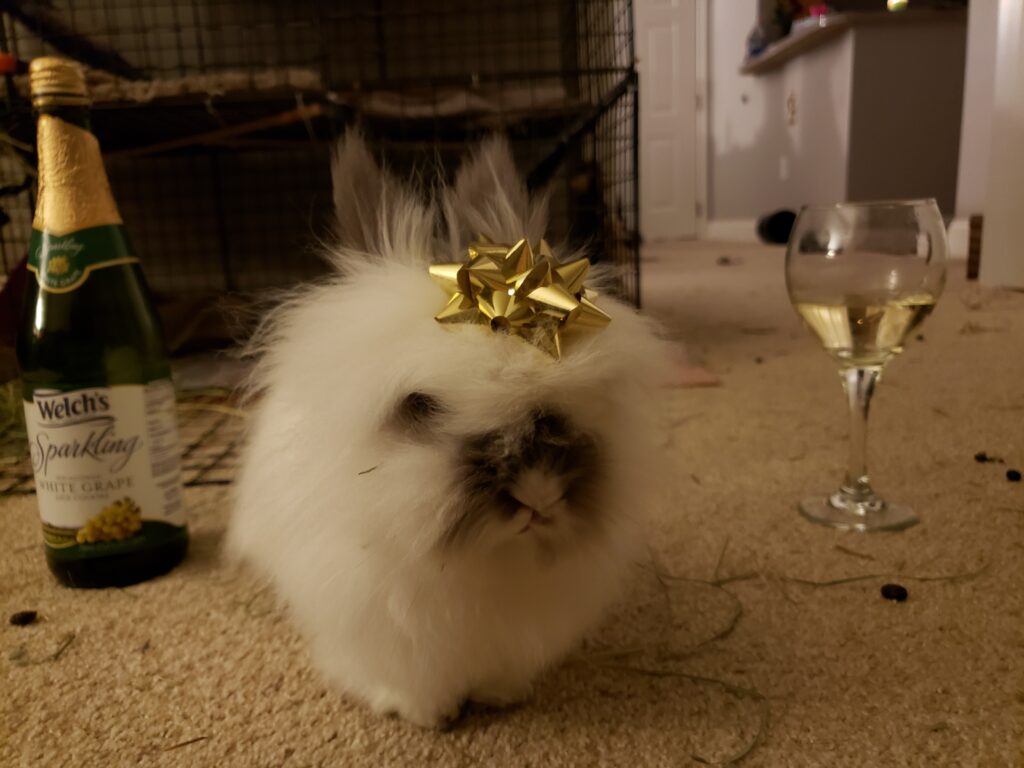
28,224 -> 138,293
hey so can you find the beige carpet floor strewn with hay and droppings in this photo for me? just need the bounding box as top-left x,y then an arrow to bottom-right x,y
0,244 -> 1024,768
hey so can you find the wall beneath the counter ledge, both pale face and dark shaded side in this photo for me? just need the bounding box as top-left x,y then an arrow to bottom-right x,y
709,5 -> 966,221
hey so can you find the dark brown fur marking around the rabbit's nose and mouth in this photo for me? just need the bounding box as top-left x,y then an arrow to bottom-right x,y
442,409 -> 601,550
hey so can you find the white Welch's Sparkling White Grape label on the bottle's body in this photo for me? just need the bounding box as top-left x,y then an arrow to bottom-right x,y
25,379 -> 185,557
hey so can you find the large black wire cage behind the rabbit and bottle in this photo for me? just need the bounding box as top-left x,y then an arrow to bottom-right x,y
0,0 -> 639,303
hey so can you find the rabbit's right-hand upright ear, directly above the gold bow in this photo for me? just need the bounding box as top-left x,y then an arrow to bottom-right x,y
443,135 -> 548,256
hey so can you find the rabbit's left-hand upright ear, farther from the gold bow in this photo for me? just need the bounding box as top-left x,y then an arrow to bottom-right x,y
331,128 -> 433,266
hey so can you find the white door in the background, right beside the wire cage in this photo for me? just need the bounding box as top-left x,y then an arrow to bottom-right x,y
634,0 -> 703,242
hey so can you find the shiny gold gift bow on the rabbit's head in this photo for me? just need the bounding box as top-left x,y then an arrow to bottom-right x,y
430,237 -> 611,359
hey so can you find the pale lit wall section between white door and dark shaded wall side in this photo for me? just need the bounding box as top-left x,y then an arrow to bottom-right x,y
708,0 -> 853,220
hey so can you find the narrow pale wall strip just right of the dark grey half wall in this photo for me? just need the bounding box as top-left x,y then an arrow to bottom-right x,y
956,0 -> 999,216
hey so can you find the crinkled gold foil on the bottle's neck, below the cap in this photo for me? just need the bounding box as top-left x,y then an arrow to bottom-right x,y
33,104 -> 121,234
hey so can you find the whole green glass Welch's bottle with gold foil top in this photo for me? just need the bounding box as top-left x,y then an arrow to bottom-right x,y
17,57 -> 188,587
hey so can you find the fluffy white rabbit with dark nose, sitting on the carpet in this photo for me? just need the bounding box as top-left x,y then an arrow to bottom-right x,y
227,134 -> 669,726
